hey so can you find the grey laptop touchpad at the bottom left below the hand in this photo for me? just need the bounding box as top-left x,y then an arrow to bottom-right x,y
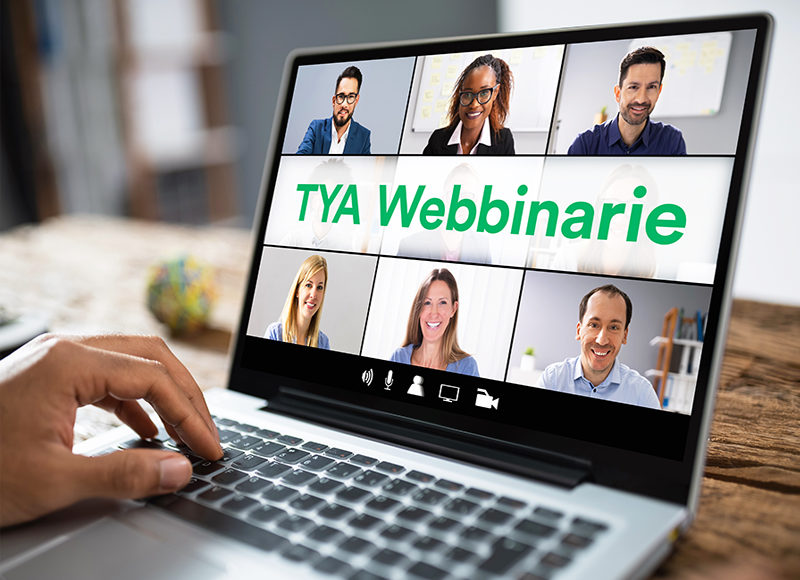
6,518 -> 225,580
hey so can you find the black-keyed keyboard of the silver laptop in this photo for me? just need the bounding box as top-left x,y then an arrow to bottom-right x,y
120,417 -> 608,580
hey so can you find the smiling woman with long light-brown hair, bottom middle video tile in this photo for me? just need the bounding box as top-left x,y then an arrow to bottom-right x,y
391,268 -> 480,377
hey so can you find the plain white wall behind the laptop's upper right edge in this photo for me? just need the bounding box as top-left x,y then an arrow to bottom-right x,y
499,0 -> 800,305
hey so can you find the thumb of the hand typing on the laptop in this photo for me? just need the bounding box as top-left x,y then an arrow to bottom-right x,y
71,449 -> 192,501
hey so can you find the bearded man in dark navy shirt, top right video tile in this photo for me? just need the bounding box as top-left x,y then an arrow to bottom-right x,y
567,46 -> 686,155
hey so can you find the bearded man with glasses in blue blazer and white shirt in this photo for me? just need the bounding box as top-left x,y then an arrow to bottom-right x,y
297,66 -> 370,155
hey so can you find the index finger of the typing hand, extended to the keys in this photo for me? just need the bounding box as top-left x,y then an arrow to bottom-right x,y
61,341 -> 222,459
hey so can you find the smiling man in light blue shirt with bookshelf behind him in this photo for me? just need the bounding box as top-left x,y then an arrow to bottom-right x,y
536,284 -> 661,409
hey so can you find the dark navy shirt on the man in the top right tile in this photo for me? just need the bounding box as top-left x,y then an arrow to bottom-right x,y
567,115 -> 686,155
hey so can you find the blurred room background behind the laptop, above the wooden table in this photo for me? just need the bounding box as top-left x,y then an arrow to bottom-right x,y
0,0 -> 800,305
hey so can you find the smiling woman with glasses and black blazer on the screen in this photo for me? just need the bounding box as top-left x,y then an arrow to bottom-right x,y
422,54 -> 514,155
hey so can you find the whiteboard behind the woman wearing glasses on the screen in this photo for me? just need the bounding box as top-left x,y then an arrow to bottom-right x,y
411,45 -> 564,133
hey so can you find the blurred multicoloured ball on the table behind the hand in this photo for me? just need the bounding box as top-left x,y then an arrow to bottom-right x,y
147,256 -> 217,334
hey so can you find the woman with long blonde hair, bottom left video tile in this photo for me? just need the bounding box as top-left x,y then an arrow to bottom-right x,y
265,254 -> 331,350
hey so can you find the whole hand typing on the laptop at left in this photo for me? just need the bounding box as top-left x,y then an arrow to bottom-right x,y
0,335 -> 222,526
